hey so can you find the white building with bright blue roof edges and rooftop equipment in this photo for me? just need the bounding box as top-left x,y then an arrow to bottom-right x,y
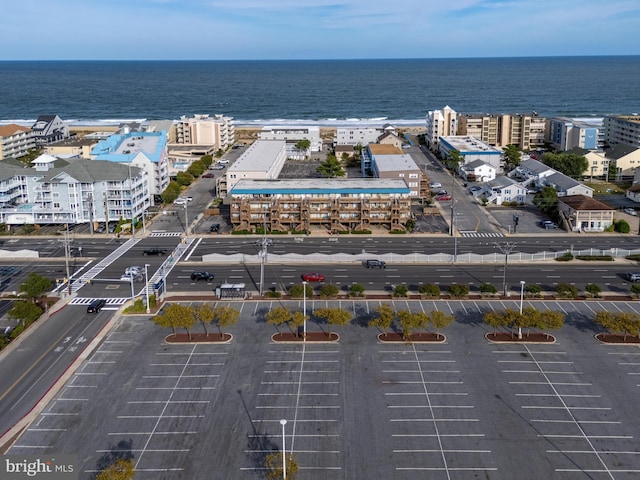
91,131 -> 169,204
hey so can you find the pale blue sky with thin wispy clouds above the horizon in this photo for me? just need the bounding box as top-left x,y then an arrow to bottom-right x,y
5,0 -> 640,60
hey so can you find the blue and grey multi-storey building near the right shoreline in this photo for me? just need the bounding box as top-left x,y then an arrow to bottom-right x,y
547,117 -> 604,151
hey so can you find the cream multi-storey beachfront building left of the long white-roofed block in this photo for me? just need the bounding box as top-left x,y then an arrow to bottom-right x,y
176,114 -> 236,150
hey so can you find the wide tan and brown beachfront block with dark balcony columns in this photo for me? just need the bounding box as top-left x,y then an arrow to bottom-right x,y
455,113 -> 547,151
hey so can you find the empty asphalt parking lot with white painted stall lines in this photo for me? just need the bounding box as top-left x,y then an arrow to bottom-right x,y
9,301 -> 640,480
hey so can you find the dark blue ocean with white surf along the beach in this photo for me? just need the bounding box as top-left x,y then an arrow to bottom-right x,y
0,56 -> 640,126
